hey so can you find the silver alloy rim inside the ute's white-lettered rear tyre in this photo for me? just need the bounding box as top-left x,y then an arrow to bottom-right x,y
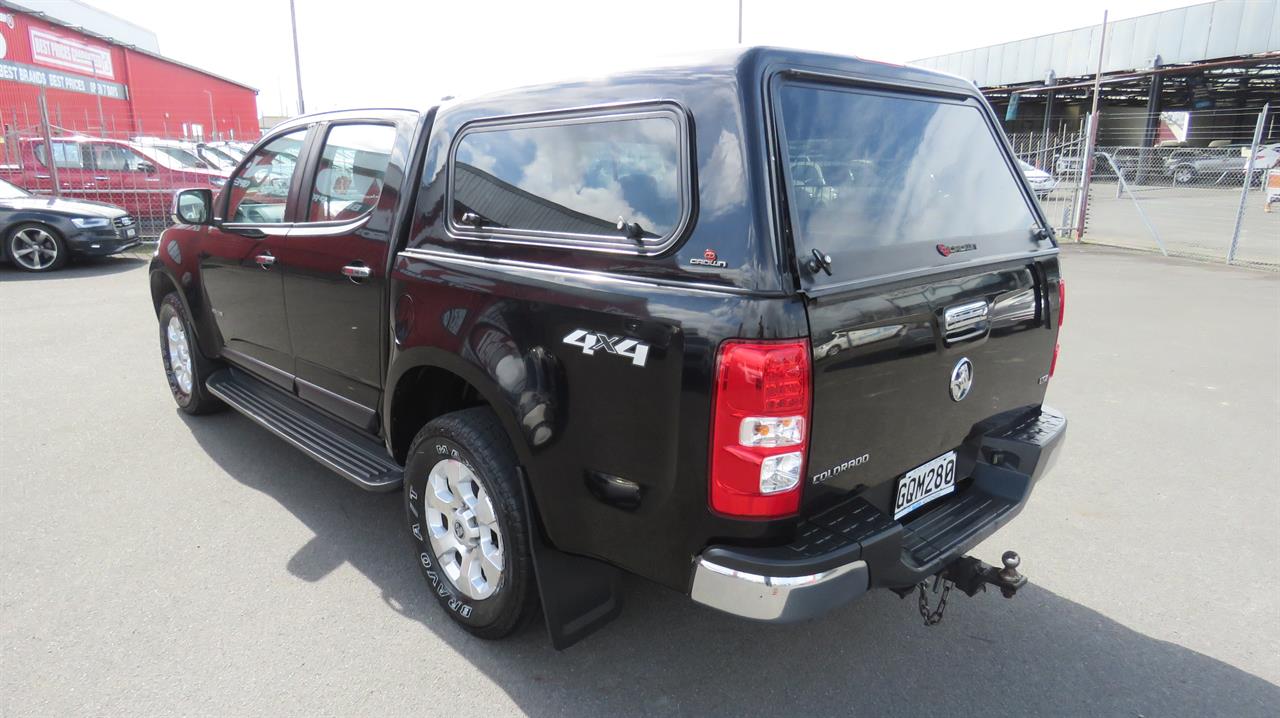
422,458 -> 504,600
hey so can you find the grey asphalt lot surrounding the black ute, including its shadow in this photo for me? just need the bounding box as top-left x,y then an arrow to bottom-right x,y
0,247 -> 1280,717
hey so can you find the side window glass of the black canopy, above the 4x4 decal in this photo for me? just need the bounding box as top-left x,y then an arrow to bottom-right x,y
451,110 -> 690,252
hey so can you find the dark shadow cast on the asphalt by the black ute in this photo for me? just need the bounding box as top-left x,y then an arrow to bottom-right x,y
183,412 -> 1280,717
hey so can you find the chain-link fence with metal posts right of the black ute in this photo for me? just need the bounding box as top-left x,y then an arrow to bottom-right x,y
1010,108 -> 1280,271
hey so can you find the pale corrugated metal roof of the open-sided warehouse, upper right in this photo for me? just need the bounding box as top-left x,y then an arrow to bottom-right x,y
910,0 -> 1280,88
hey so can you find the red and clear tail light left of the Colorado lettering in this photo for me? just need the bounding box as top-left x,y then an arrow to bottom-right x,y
709,340 -> 812,518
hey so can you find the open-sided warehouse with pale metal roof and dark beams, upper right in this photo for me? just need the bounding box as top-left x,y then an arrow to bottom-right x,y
913,0 -> 1280,147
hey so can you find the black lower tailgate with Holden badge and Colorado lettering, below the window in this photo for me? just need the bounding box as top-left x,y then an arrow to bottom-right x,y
805,259 -> 1057,513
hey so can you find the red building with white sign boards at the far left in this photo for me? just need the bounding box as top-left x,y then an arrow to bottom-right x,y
0,3 -> 260,140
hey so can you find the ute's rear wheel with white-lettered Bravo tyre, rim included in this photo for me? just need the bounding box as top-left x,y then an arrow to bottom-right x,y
404,407 -> 536,639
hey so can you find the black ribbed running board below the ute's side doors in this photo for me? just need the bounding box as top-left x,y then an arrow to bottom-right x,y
205,369 -> 404,491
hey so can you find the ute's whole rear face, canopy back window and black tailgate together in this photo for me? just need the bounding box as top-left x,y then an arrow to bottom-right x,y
773,78 -> 1059,513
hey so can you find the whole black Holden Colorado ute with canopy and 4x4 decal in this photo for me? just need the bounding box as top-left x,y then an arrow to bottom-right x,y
150,47 -> 1066,646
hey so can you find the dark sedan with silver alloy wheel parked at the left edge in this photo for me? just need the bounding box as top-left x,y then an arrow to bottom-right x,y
0,179 -> 140,271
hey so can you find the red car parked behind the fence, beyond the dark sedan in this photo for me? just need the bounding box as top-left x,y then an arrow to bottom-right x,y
0,136 -> 227,234
